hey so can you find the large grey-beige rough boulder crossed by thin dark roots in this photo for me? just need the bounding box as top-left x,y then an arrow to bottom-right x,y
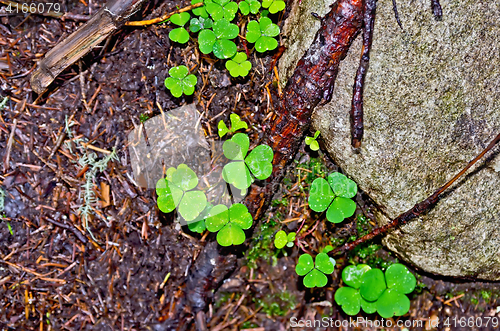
280,0 -> 500,280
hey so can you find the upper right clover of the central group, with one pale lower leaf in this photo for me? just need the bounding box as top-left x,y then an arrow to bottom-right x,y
222,133 -> 274,190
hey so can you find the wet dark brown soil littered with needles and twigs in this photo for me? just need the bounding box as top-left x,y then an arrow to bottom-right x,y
0,1 -> 500,330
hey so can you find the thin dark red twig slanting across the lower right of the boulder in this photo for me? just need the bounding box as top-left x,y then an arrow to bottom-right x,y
330,134 -> 500,255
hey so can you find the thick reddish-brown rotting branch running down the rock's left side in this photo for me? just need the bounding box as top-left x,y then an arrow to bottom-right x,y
245,0 -> 364,219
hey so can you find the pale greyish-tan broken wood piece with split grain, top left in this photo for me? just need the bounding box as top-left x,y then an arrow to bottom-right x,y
31,0 -> 146,94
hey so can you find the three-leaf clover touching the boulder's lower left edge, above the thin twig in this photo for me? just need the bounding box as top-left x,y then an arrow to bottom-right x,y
308,172 -> 358,223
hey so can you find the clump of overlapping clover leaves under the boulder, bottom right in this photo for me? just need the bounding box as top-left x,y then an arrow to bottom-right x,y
335,263 -> 416,318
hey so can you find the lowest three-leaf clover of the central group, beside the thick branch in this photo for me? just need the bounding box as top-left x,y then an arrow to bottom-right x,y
205,203 -> 253,246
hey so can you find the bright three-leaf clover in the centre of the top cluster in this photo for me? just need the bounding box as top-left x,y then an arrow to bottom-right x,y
198,19 -> 239,59
